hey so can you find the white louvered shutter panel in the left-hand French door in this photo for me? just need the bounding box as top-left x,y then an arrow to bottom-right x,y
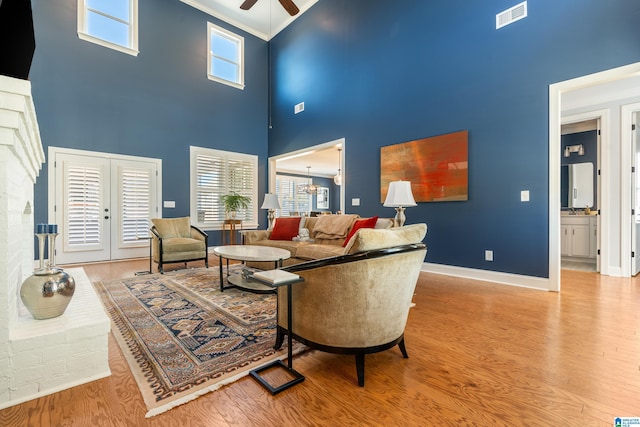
64,164 -> 104,250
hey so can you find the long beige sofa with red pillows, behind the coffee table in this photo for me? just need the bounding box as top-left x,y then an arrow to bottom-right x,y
242,214 -> 394,269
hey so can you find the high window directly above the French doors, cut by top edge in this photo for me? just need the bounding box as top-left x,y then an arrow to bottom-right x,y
78,0 -> 138,56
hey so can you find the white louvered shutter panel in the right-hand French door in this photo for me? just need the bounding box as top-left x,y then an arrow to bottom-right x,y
119,168 -> 151,245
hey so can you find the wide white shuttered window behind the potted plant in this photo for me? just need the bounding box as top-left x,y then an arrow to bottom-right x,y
191,147 -> 258,229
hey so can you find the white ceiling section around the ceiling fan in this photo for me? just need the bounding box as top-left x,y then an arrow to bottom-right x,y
180,0 -> 318,40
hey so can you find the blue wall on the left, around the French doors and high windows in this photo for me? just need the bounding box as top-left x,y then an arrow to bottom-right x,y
30,0 -> 268,244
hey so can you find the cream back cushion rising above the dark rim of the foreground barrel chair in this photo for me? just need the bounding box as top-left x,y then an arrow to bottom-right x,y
345,224 -> 427,254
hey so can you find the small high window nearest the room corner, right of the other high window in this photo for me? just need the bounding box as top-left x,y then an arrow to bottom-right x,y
207,22 -> 244,89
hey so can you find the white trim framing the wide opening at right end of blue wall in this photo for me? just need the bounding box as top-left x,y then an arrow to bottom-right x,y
548,63 -> 640,292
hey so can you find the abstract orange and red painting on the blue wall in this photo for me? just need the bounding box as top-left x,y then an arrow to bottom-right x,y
380,130 -> 469,203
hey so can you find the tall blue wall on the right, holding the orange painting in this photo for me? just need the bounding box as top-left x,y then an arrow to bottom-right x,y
269,0 -> 640,277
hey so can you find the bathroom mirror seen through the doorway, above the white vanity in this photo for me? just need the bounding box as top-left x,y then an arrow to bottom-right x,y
560,162 -> 594,209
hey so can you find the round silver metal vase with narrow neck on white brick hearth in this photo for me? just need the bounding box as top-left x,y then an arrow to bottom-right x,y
20,224 -> 76,320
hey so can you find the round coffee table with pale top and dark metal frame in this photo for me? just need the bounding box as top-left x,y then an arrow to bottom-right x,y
213,245 -> 291,293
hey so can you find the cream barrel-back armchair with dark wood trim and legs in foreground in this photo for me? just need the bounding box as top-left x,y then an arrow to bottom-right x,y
275,224 -> 427,386
